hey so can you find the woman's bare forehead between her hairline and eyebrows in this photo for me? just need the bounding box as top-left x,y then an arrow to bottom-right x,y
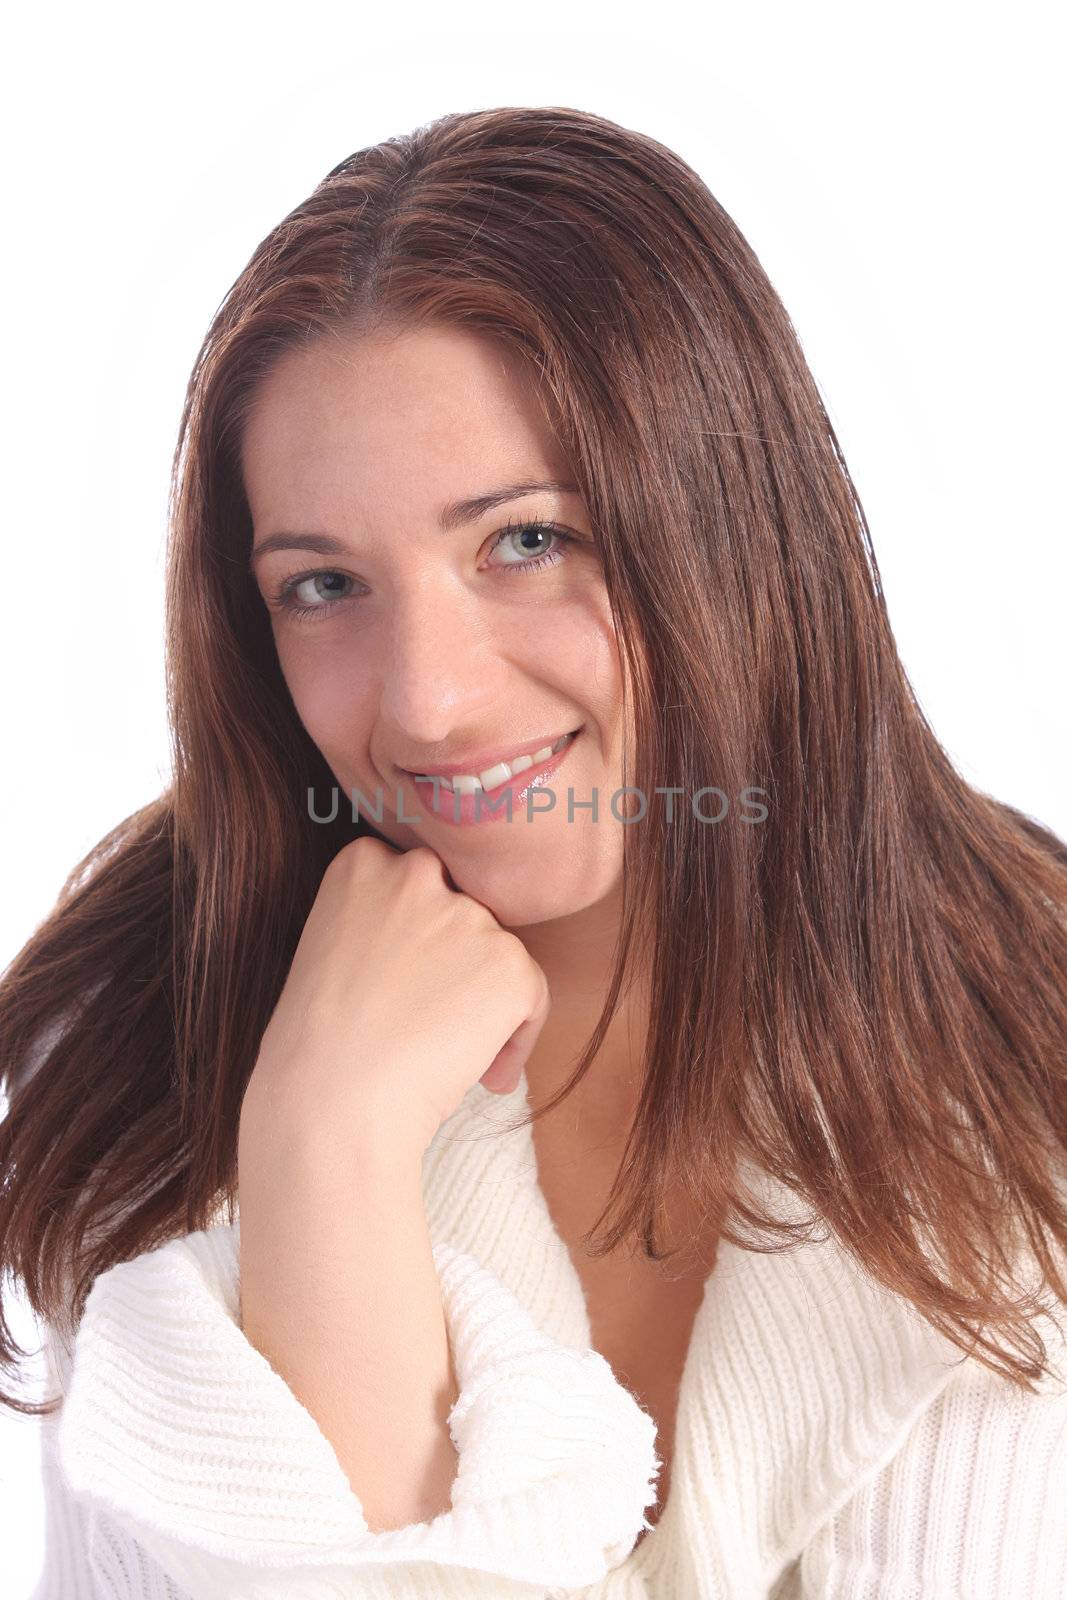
242,325 -> 565,520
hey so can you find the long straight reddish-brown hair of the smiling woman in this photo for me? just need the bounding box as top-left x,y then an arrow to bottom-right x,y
0,107 -> 1067,1411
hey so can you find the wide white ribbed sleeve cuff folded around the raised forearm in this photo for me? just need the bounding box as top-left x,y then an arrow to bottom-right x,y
56,1222 -> 659,1600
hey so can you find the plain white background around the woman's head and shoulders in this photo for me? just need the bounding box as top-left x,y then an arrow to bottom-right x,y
0,0 -> 1067,1600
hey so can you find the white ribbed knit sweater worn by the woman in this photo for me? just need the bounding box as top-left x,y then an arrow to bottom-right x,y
22,1077 -> 1067,1600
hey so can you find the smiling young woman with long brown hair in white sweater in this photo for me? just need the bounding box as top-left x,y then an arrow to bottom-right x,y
0,107 -> 1067,1600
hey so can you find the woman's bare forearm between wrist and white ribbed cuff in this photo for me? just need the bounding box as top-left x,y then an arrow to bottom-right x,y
238,1104 -> 458,1533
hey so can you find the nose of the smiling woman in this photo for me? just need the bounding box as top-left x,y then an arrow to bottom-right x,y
381,574 -> 502,750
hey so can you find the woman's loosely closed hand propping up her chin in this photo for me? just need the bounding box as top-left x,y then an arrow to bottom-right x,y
242,837 -> 549,1150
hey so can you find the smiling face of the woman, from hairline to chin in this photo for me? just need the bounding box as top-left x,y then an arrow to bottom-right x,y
242,325 -> 629,926
